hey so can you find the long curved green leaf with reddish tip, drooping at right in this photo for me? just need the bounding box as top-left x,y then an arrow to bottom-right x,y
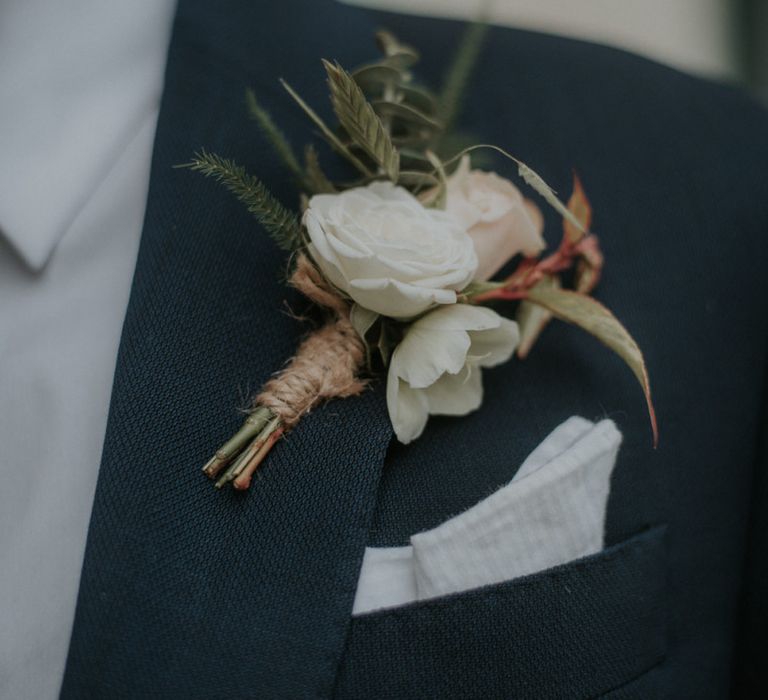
528,286 -> 659,446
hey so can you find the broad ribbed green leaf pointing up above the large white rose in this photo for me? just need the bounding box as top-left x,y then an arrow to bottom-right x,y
323,60 -> 400,182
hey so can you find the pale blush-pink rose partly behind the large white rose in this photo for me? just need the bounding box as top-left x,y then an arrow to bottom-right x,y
445,156 -> 544,280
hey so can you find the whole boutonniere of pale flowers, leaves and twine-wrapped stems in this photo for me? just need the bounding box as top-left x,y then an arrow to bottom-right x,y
187,25 -> 657,489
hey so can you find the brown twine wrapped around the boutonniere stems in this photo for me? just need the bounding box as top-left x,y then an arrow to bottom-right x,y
254,254 -> 366,430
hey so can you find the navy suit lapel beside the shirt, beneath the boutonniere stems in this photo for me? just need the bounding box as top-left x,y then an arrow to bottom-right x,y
62,1 -> 390,697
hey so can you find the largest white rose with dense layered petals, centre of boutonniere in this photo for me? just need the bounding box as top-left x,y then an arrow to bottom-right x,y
304,182 -> 477,318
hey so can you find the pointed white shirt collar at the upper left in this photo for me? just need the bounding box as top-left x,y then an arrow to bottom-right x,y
0,0 -> 173,271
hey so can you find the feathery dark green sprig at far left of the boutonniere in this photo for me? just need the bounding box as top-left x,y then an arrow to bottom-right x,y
186,151 -> 302,251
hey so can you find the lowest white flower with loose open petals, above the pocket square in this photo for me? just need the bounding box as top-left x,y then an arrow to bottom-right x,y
387,304 -> 519,443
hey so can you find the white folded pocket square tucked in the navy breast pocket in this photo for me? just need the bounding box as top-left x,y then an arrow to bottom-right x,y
352,416 -> 621,615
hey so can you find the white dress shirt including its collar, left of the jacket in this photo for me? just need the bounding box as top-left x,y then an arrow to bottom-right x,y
0,0 -> 175,700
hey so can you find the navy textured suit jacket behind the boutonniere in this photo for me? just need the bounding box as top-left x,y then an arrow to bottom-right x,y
62,0 -> 768,698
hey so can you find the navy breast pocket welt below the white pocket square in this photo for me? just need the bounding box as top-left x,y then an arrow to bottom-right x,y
336,526 -> 666,699
